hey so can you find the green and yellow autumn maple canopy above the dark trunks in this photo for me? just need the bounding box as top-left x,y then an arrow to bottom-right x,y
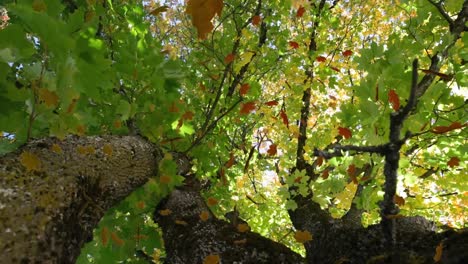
0,0 -> 468,263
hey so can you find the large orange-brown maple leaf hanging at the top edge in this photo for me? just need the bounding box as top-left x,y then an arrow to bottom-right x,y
185,0 -> 224,39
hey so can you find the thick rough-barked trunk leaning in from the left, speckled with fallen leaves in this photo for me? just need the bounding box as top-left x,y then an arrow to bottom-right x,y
0,136 -> 161,263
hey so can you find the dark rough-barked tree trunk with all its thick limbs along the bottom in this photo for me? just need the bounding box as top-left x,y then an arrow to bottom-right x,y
0,136 -> 468,264
